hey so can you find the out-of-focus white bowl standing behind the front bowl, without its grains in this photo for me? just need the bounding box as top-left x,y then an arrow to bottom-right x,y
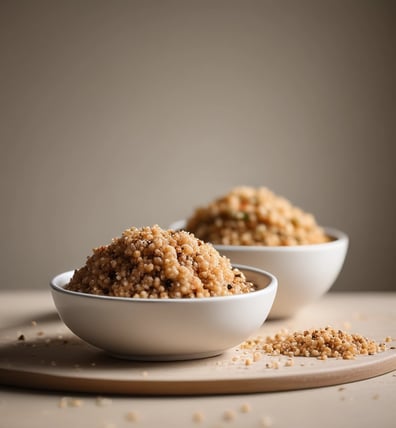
170,220 -> 349,318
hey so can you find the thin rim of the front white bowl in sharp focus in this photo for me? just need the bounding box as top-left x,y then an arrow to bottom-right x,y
49,264 -> 278,305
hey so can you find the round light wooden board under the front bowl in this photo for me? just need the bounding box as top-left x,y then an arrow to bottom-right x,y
0,314 -> 396,395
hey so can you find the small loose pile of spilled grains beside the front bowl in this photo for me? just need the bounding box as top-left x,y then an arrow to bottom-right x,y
241,327 -> 386,360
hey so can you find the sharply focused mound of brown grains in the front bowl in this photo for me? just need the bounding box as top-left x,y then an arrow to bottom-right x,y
66,225 -> 255,299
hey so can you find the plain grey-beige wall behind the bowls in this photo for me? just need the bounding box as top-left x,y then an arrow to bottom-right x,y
0,0 -> 396,290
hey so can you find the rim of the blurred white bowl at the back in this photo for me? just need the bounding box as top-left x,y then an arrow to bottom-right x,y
169,220 -> 349,252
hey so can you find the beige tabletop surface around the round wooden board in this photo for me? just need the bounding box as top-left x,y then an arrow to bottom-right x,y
0,291 -> 396,428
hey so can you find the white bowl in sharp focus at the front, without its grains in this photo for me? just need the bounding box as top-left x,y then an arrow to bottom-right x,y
50,266 -> 277,361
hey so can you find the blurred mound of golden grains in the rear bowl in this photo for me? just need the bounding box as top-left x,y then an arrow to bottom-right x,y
186,186 -> 330,246
